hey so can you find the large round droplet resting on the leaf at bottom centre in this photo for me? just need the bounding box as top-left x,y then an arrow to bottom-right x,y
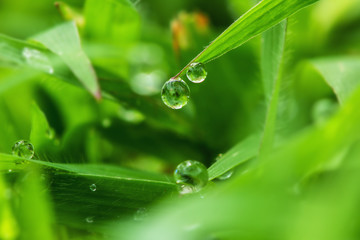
174,160 -> 209,194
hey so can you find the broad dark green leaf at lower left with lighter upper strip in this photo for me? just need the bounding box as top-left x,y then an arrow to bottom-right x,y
0,154 -> 176,229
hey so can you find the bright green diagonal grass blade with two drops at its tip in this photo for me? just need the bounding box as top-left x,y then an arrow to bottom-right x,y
176,0 -> 318,76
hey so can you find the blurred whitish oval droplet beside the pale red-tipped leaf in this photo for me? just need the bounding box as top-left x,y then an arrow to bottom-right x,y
22,47 -> 54,74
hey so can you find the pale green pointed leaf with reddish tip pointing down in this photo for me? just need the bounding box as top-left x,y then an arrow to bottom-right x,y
33,22 -> 101,99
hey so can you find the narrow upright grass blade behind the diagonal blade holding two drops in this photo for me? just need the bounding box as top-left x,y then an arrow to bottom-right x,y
259,20 -> 287,157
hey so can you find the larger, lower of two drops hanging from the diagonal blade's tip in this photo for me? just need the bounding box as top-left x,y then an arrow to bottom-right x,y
161,78 -> 190,109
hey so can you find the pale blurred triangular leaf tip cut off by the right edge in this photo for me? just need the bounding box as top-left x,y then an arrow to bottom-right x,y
310,57 -> 360,104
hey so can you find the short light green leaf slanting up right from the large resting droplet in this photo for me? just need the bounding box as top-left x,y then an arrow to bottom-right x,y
208,134 -> 260,180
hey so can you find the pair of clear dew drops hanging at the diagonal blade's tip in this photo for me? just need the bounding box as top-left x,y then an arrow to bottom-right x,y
161,63 -> 207,109
